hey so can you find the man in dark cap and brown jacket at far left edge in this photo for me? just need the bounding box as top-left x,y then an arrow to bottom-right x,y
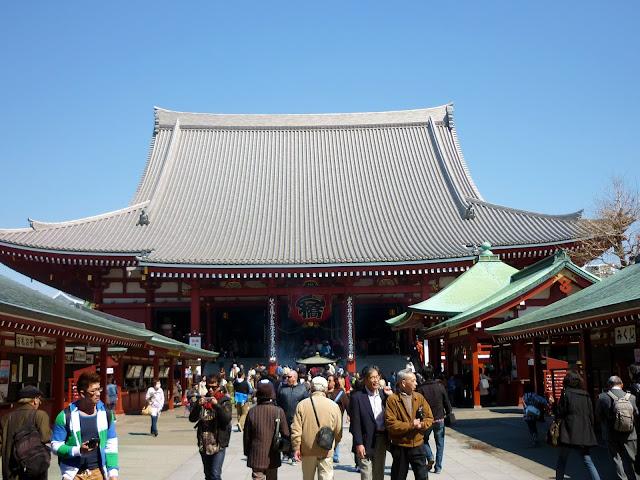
0,385 -> 51,480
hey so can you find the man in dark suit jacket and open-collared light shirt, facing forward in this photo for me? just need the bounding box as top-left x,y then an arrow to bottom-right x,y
349,365 -> 392,480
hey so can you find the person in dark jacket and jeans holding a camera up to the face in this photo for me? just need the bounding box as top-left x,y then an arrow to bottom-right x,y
189,375 -> 231,480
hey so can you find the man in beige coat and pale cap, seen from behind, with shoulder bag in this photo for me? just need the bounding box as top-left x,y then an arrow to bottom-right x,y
291,377 -> 342,480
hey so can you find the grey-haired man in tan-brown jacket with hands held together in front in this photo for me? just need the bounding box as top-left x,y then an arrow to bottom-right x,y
385,369 -> 433,480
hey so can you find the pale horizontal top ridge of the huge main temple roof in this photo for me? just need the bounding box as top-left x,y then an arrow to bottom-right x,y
154,103 -> 453,132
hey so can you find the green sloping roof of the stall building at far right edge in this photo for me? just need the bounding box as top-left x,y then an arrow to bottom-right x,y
486,264 -> 640,335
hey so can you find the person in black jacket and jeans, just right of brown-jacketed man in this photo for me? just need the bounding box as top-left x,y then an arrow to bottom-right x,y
416,365 -> 451,473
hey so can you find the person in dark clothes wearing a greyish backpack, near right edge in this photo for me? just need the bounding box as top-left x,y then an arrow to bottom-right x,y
596,375 -> 640,480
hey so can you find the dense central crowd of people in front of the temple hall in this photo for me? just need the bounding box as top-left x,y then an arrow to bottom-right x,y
175,361 -> 451,480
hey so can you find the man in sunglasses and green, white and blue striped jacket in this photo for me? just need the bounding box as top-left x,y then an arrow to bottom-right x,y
51,372 -> 118,480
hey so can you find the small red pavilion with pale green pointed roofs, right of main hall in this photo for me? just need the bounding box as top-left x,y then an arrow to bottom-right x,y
387,243 -> 599,407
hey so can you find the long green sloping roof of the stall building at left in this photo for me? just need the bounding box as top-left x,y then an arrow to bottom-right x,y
0,275 -> 218,358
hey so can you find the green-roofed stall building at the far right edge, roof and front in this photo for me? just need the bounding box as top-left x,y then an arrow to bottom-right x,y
486,257 -> 640,404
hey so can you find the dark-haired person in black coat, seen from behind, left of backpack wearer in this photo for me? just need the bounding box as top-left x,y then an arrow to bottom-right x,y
553,371 -> 600,480
